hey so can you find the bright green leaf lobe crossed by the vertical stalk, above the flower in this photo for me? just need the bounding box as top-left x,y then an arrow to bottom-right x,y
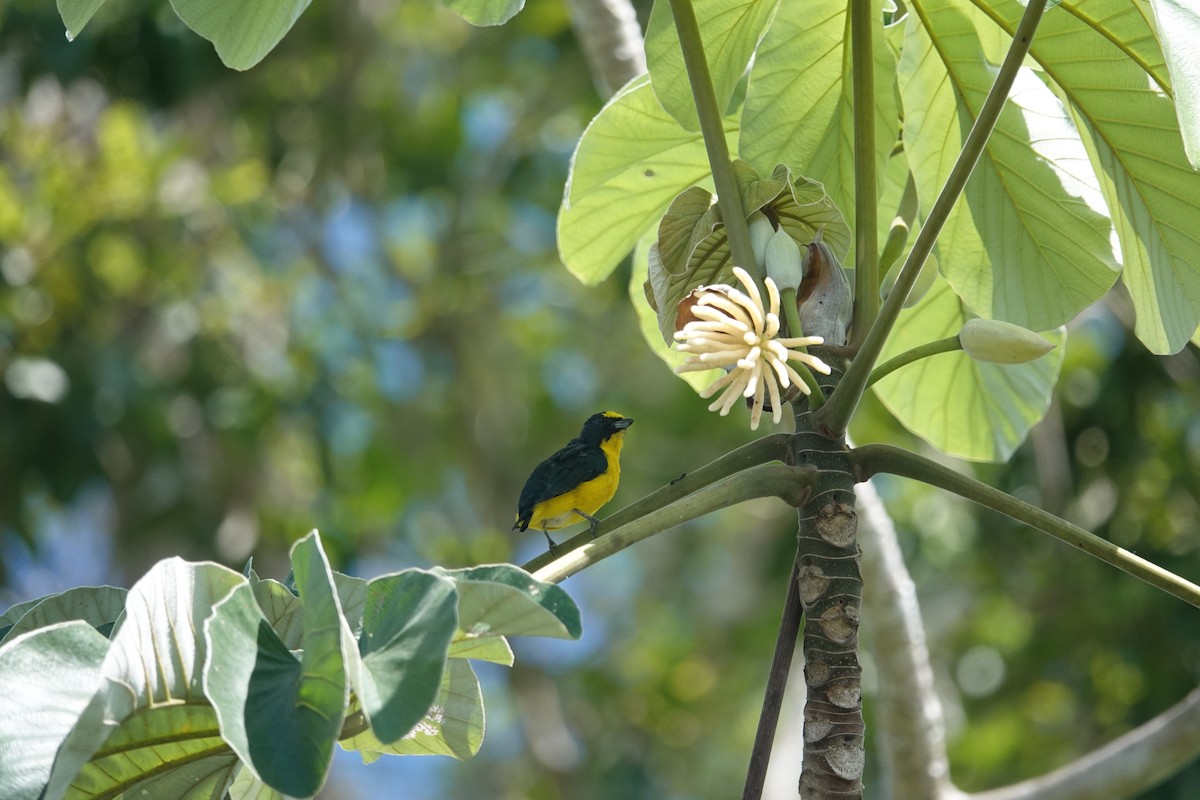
738,0 -> 899,242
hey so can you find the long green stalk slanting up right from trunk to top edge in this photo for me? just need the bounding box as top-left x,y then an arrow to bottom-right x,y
815,0 -> 1046,435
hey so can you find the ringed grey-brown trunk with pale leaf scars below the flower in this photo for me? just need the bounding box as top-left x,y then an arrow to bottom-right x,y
792,371 -> 866,798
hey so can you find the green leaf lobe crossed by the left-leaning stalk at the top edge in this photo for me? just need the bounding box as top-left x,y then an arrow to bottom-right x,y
646,0 -> 779,131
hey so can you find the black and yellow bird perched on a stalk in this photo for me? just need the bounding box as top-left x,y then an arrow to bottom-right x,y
512,411 -> 634,552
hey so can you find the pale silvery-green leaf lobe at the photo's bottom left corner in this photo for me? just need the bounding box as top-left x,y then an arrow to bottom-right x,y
0,620 -> 108,800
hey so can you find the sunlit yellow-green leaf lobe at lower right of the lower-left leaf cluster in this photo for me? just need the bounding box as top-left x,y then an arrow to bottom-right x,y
341,658 -> 484,763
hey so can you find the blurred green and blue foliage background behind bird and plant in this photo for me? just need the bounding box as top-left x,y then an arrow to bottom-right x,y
0,0 -> 1200,800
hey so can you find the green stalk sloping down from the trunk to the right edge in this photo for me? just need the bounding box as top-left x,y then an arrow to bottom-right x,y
851,445 -> 1200,607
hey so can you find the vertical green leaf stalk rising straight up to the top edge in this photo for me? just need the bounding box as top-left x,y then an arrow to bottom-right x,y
850,0 -> 880,348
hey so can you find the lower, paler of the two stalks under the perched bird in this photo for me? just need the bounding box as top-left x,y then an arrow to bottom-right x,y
527,464 -> 820,583
